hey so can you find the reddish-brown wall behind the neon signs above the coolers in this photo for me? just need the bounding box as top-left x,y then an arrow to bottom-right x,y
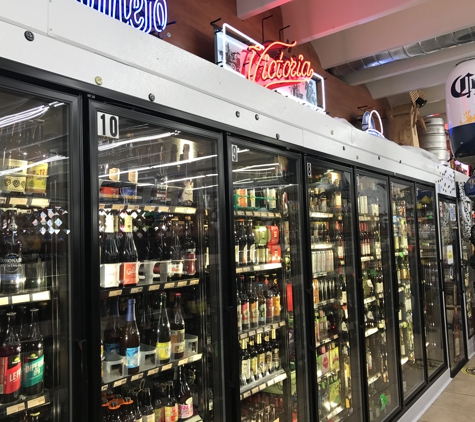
164,0 -> 394,139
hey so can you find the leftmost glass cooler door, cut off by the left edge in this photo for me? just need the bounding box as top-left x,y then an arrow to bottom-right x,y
0,82 -> 74,421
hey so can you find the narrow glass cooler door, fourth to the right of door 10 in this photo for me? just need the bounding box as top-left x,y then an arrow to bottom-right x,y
391,182 -> 425,400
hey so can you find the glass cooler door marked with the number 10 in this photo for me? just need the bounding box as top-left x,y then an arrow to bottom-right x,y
94,104 -> 225,422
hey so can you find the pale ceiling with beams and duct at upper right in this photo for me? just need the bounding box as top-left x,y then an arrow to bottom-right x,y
236,0 -> 475,120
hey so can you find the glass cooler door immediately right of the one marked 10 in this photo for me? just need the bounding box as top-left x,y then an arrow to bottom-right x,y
232,144 -> 309,422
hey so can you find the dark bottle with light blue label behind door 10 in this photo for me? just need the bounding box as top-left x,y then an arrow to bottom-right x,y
120,299 -> 140,375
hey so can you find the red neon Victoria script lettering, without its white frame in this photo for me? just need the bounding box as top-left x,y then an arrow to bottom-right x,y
242,41 -> 314,89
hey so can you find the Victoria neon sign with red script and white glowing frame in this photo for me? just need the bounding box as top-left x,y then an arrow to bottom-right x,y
215,24 -> 325,112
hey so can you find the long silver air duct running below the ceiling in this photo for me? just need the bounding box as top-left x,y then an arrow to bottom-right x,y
327,26 -> 475,78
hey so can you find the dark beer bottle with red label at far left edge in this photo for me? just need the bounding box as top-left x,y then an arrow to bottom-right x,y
0,312 -> 21,404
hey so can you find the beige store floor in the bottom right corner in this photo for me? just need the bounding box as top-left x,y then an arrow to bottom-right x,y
419,356 -> 475,422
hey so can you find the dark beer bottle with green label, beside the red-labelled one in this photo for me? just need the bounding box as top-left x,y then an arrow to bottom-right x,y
21,308 -> 44,396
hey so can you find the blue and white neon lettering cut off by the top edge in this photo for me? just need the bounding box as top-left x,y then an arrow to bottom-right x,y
77,0 -> 168,34
